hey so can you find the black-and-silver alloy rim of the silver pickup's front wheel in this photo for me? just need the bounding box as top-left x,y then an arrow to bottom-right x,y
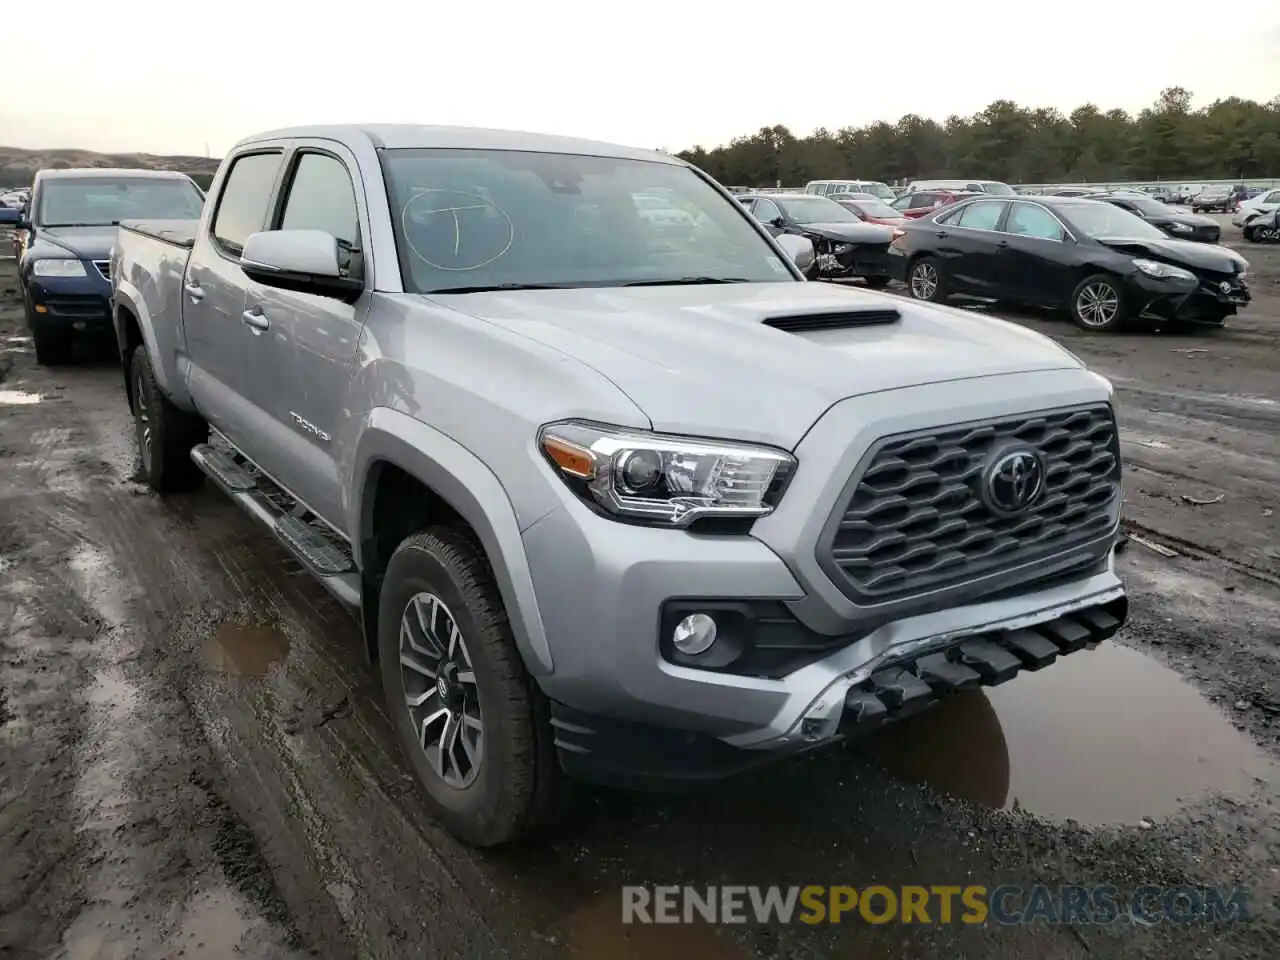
399,593 -> 484,790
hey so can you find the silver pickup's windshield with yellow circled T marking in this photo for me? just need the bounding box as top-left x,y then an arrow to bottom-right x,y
381,148 -> 788,293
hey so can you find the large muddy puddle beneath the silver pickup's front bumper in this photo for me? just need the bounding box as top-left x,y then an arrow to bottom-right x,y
855,643 -> 1277,824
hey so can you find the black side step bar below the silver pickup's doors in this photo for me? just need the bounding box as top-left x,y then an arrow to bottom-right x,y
191,439 -> 360,611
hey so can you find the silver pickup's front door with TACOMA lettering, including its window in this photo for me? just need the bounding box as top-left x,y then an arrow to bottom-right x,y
244,141 -> 369,530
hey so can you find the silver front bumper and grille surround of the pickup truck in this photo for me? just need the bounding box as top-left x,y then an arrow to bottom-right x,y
524,370 -> 1124,776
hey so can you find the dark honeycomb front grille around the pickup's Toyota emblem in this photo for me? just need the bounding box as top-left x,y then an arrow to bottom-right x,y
818,404 -> 1120,603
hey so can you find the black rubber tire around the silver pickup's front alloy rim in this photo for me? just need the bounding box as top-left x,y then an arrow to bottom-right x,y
378,527 -> 566,847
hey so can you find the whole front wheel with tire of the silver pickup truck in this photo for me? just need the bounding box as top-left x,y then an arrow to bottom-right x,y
378,527 -> 563,846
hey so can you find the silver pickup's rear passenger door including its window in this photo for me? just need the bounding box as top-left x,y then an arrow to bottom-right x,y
182,148 -> 284,440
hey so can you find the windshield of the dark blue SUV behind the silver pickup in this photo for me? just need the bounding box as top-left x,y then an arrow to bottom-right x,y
36,177 -> 205,227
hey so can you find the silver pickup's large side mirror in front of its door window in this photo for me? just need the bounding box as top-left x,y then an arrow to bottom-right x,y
239,230 -> 365,303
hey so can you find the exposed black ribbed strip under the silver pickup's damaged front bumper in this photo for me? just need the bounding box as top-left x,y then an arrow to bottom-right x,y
840,596 -> 1129,736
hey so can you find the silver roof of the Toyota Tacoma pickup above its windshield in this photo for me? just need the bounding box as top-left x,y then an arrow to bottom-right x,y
236,123 -> 684,165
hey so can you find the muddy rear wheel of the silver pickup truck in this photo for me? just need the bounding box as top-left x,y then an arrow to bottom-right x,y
129,347 -> 209,493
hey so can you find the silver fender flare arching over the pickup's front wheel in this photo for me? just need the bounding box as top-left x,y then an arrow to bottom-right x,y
347,407 -> 554,676
